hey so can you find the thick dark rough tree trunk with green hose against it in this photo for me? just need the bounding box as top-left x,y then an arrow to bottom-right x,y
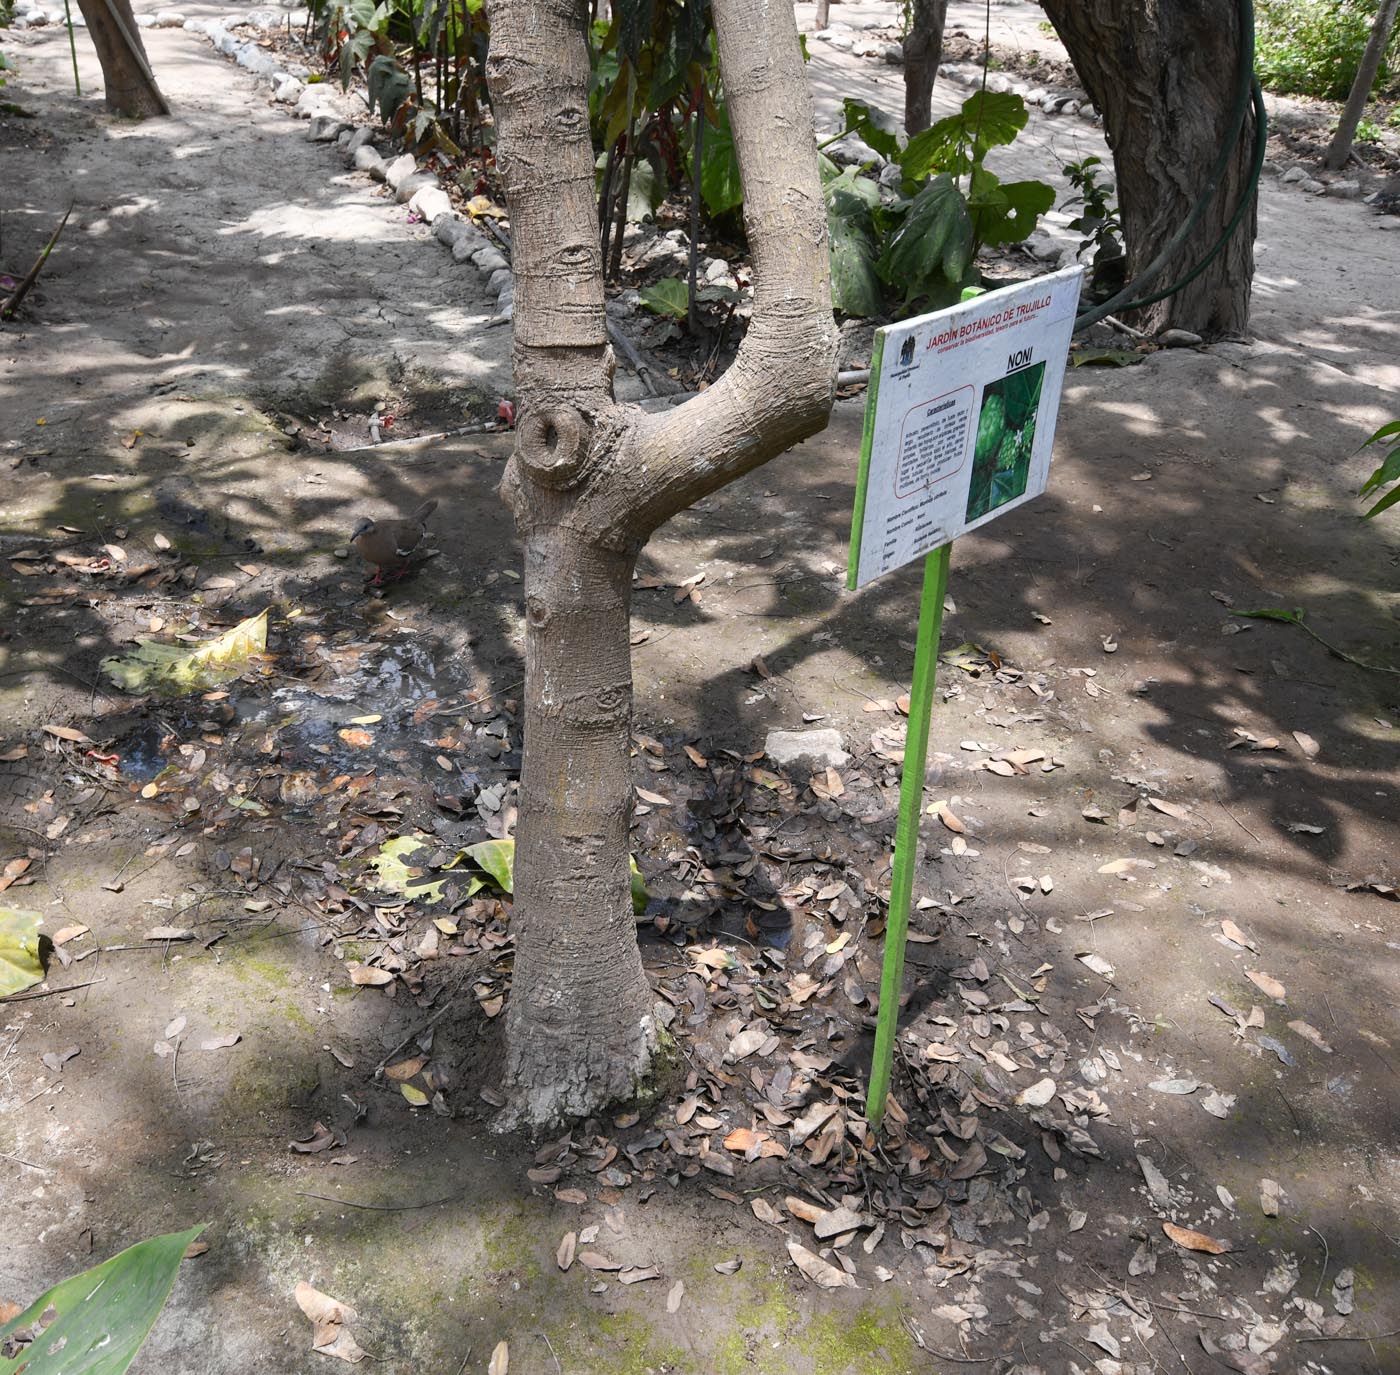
1044,0 -> 1256,337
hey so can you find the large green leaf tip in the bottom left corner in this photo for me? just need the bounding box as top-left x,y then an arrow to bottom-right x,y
0,1224 -> 206,1375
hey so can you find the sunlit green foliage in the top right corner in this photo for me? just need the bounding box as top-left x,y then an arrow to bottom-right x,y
1254,0 -> 1400,101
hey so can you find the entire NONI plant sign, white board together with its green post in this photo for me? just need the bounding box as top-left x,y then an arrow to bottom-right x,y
847,267 -> 1084,1129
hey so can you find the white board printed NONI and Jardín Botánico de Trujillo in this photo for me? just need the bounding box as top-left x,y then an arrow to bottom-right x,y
847,267 -> 1084,588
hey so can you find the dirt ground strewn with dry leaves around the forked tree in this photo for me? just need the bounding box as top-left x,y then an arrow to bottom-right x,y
0,6 -> 1400,1375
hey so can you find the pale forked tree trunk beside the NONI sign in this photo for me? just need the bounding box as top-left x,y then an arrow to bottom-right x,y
487,0 -> 836,1127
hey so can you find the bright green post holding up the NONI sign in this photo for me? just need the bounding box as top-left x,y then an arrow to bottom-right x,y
865,542 -> 953,1127
